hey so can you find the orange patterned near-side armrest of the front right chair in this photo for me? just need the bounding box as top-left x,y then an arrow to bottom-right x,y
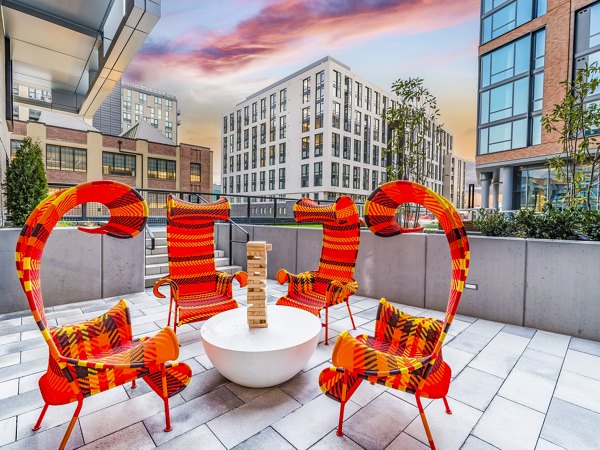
331,331 -> 433,378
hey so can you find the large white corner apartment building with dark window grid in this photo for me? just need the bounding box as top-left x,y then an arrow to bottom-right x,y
221,56 -> 453,202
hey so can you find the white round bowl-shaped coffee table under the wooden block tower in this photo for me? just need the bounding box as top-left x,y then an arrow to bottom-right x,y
200,305 -> 322,388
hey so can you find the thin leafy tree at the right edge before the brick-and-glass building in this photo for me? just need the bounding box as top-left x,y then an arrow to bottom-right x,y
542,65 -> 600,209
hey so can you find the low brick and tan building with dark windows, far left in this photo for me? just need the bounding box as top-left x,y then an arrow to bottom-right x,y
11,111 -> 213,207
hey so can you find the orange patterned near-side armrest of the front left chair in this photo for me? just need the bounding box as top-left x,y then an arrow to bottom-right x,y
58,328 -> 179,370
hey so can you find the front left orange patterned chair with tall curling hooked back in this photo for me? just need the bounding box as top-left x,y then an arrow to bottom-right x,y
16,181 -> 191,449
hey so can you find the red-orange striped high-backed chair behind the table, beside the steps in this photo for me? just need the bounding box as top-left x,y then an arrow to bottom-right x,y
154,195 -> 248,332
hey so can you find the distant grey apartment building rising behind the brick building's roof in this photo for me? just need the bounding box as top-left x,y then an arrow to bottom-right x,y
92,81 -> 181,144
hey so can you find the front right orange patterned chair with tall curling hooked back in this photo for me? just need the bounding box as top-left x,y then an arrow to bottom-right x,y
319,181 -> 469,449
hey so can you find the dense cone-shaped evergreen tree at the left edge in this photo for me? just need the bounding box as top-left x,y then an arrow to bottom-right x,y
4,138 -> 48,227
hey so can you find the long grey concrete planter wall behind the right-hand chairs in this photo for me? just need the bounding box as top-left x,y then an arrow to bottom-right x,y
217,225 -> 600,340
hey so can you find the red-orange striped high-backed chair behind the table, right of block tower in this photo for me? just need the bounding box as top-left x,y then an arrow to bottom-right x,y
277,197 -> 360,345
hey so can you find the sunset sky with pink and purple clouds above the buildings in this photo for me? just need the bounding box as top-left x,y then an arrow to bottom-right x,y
124,0 -> 480,182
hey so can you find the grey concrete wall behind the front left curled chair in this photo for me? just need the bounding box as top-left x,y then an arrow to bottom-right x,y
0,228 -> 144,313
